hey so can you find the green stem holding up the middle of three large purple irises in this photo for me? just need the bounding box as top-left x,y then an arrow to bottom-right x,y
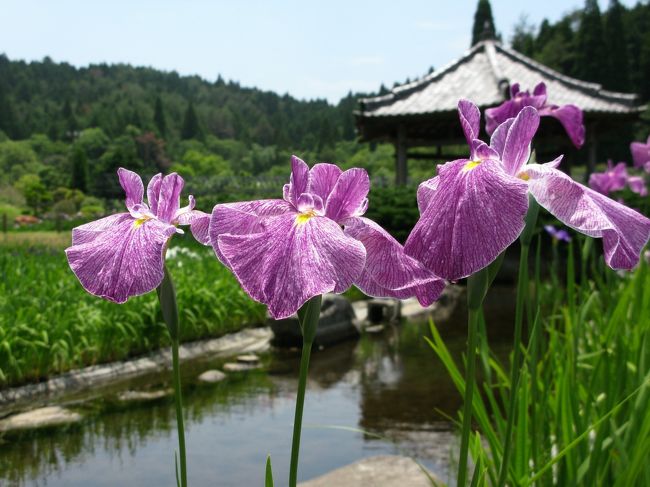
289,295 -> 322,487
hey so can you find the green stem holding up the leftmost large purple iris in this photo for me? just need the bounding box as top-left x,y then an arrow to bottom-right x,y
156,267 -> 187,487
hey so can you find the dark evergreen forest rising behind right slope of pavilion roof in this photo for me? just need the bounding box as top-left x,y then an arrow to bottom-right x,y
512,0 -> 650,101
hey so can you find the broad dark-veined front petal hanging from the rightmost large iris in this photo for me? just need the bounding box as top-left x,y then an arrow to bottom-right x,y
404,159 -> 528,280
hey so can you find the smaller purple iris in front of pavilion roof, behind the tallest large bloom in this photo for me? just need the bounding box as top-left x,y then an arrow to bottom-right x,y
484,82 -> 585,149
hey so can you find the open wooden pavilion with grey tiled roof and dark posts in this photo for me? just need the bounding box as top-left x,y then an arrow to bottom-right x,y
355,39 -> 644,185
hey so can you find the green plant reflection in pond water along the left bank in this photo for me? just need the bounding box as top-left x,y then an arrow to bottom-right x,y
0,373 -> 276,485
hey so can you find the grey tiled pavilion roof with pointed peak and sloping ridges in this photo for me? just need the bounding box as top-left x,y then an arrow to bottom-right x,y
357,40 -> 640,124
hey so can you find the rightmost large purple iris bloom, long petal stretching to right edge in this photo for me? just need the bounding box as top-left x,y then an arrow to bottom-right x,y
405,100 -> 650,280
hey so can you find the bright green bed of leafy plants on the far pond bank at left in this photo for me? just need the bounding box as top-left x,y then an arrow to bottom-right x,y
0,232 -> 265,387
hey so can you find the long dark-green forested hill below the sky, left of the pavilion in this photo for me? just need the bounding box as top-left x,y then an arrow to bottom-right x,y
0,55 -> 356,149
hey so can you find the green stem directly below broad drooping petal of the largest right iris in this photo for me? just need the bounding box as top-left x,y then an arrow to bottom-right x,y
457,268 -> 490,487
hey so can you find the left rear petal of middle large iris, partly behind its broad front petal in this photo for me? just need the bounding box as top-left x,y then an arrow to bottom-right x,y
209,200 -> 296,266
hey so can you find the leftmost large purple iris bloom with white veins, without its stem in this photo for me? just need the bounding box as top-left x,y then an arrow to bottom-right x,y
65,168 -> 209,303
